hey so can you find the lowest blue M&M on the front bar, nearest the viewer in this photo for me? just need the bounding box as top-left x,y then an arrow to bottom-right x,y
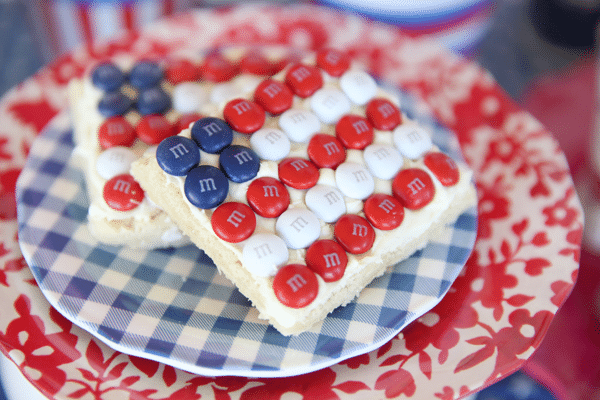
183,165 -> 229,209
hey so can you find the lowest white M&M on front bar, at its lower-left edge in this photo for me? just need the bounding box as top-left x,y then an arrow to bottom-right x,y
242,233 -> 289,277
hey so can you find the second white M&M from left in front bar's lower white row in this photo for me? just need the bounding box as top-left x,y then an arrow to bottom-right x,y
275,208 -> 321,249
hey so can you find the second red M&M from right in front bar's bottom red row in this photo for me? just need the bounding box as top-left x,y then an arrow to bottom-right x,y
392,168 -> 435,210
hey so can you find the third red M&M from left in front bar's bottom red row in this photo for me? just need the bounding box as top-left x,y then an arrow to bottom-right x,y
333,214 -> 375,254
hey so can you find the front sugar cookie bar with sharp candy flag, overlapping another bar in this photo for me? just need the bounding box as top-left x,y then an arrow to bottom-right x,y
131,49 -> 476,335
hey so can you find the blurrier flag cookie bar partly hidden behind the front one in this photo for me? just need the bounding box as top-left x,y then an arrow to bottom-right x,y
69,48 -> 287,249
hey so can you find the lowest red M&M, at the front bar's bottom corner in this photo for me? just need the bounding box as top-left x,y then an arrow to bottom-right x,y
273,264 -> 319,308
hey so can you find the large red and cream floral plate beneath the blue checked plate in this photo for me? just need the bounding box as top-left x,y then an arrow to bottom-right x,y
0,5 -> 583,399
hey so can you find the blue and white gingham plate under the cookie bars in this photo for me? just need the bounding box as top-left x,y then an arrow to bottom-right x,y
17,90 -> 477,377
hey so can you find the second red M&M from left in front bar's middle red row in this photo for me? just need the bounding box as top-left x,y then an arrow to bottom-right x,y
246,176 -> 290,218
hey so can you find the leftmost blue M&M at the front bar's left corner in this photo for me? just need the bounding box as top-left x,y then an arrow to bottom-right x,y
156,136 -> 200,176
